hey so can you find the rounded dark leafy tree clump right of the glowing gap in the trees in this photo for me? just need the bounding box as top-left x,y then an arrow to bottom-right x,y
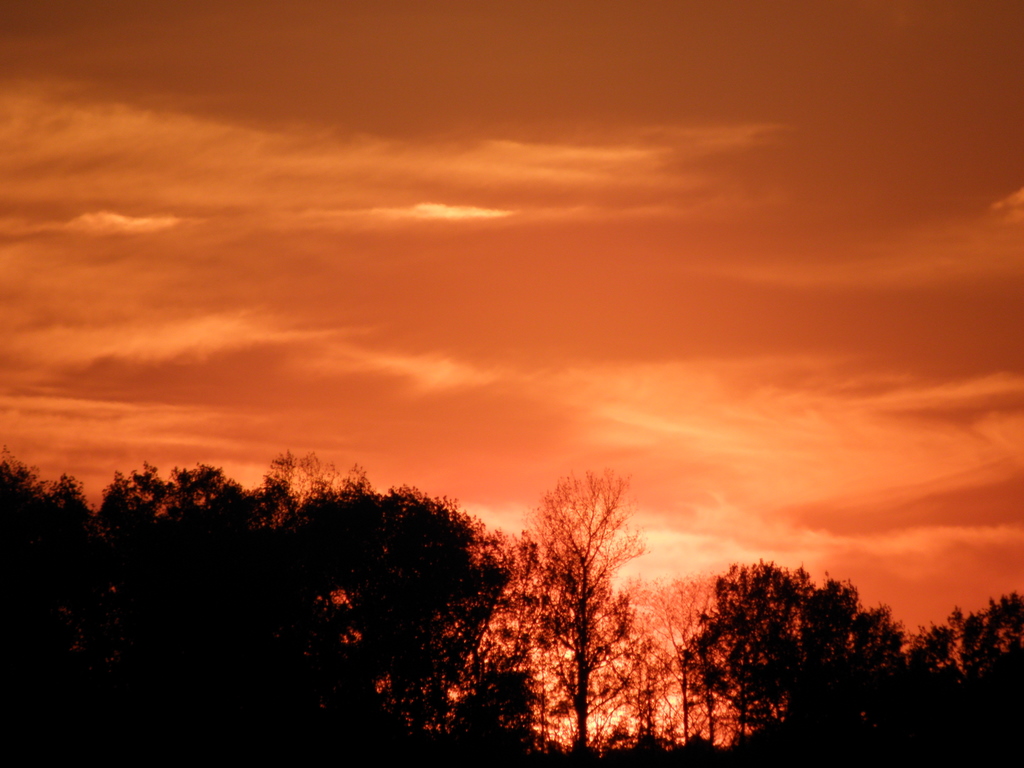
698,562 -> 903,742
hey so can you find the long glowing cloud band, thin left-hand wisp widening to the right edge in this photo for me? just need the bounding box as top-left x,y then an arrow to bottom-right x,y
280,340 -> 1024,528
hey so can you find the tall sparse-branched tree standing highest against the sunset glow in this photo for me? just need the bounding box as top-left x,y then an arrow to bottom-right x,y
531,470 -> 643,752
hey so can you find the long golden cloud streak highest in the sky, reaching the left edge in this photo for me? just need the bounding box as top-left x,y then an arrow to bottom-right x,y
0,90 -> 778,233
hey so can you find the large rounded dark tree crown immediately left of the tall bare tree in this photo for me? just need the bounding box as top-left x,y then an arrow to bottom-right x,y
300,486 -> 516,737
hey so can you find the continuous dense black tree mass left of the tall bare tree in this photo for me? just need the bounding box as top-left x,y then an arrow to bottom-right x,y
0,455 -> 531,750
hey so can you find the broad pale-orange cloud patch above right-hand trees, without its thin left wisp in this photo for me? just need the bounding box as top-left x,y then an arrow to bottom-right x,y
528,360 -> 1024,514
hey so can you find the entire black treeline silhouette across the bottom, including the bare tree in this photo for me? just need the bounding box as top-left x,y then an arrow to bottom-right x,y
0,453 -> 1024,765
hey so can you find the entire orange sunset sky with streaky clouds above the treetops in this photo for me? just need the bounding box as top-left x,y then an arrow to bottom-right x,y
0,0 -> 1024,629
